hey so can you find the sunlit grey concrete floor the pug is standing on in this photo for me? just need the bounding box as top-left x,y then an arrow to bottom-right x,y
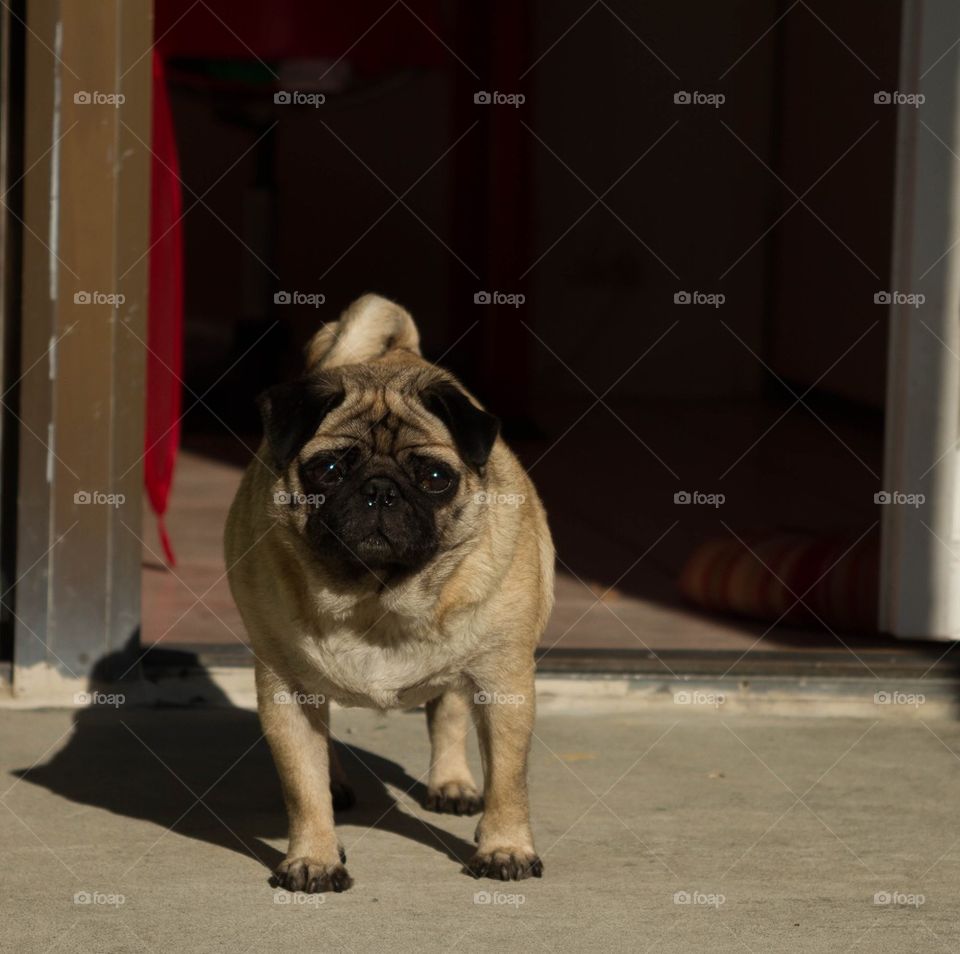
0,706 -> 960,954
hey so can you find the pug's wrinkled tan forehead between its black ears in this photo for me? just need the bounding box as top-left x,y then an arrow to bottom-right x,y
302,384 -> 457,462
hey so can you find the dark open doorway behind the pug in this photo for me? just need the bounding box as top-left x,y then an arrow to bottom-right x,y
144,2 -> 920,672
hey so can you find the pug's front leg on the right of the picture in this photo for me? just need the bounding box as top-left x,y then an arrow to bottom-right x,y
468,666 -> 543,881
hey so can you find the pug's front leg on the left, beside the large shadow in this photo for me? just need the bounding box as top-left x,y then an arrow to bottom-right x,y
257,664 -> 353,894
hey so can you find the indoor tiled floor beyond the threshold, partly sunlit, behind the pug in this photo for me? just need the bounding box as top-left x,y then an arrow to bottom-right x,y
143,394 -> 880,651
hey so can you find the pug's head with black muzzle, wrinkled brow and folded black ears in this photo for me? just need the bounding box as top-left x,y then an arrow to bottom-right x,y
261,365 -> 498,579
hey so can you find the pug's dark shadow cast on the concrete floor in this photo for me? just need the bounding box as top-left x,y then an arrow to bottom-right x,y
13,651 -> 474,871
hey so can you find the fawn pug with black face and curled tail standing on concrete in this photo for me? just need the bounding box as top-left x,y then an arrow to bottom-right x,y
225,295 -> 554,893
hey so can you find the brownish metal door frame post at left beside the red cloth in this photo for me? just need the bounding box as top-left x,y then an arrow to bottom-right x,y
4,0 -> 153,698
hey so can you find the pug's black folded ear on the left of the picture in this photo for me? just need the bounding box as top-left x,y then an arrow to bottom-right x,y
257,378 -> 344,469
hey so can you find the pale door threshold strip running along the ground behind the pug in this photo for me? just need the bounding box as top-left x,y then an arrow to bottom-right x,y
0,643 -> 960,719
